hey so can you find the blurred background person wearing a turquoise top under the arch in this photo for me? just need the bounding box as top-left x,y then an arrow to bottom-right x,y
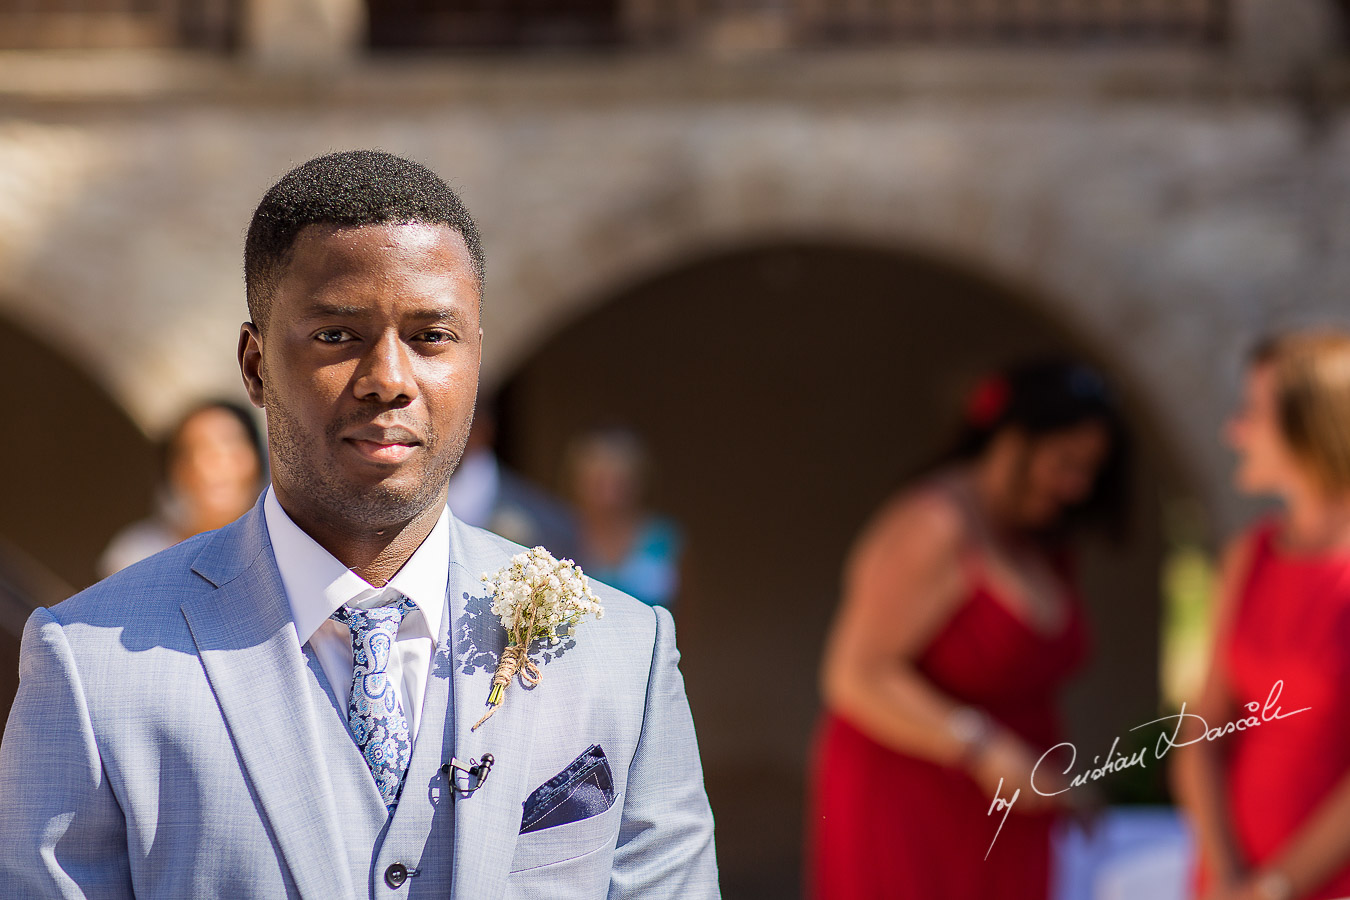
566,428 -> 680,609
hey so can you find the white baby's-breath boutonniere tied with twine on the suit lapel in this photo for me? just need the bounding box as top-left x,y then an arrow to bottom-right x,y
470,546 -> 605,731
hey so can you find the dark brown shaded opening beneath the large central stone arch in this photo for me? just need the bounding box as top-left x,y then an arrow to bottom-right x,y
501,242 -> 1181,897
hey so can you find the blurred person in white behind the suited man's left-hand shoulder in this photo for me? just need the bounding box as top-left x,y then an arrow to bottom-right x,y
99,401 -> 265,576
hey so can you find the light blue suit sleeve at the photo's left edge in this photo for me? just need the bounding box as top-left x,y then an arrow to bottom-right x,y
0,609 -> 134,900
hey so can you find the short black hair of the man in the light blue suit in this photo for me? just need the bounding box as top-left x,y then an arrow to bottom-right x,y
244,150 -> 485,328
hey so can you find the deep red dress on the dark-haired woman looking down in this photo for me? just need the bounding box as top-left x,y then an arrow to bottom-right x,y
807,555 -> 1087,900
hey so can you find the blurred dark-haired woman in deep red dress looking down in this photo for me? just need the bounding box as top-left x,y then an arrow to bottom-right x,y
807,363 -> 1123,900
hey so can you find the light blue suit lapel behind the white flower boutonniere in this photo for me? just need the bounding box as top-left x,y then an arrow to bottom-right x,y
450,519 -> 539,899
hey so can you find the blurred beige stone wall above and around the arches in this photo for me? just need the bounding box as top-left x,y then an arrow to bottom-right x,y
0,54 -> 1350,529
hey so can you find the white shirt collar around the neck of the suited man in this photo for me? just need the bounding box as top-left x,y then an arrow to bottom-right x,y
263,486 -> 450,645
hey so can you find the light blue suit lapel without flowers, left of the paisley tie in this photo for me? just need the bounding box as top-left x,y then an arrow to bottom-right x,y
182,502 -> 355,900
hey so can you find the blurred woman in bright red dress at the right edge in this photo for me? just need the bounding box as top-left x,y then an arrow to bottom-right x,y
1173,332 -> 1350,900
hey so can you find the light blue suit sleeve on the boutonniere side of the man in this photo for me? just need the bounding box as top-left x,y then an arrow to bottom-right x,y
609,607 -> 720,900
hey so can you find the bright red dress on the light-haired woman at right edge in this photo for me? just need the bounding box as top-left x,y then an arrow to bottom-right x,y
1208,521 -> 1350,900
